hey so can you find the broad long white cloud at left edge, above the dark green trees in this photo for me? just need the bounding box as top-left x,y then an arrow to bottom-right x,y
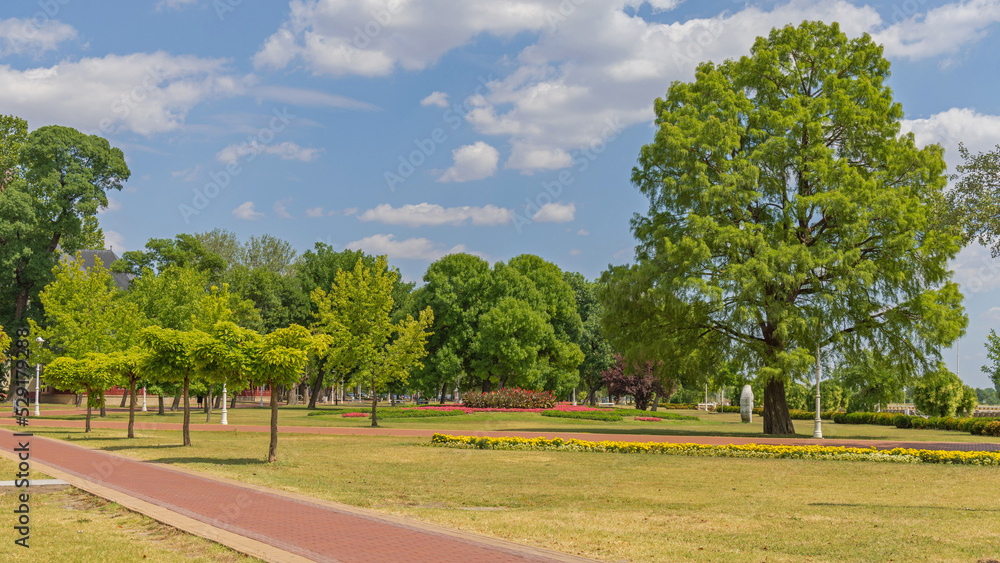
0,51 -> 245,135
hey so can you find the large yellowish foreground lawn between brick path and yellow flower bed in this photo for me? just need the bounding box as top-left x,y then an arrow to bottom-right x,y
21,428 -> 1000,561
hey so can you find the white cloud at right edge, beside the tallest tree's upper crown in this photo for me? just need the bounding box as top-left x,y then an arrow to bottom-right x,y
901,108 -> 1000,167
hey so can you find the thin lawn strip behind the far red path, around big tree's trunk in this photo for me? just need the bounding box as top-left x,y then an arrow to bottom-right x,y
27,404 -> 997,442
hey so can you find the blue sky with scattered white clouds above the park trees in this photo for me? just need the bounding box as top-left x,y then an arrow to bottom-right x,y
0,0 -> 1000,387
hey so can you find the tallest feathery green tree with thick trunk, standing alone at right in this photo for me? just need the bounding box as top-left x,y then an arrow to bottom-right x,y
605,22 -> 967,434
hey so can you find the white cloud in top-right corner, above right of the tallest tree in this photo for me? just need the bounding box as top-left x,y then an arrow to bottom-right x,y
872,0 -> 1000,59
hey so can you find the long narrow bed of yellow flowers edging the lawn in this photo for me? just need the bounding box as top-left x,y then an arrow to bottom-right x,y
431,434 -> 1000,466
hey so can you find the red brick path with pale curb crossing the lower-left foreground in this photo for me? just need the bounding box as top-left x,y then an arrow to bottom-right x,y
0,430 -> 587,563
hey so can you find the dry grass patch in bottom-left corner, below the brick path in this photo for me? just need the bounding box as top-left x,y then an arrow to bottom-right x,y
0,458 -> 259,563
